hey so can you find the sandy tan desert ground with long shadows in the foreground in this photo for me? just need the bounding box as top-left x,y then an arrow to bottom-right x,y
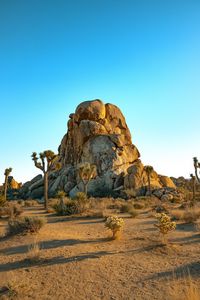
0,207 -> 200,300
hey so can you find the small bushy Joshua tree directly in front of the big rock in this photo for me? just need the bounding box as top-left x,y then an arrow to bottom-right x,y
77,162 -> 97,195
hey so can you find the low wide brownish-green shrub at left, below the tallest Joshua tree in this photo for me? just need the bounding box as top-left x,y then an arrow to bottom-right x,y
7,217 -> 46,235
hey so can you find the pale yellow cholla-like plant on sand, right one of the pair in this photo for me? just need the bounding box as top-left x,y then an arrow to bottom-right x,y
154,213 -> 176,244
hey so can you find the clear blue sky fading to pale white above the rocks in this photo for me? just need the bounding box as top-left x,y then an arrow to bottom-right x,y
0,0 -> 200,183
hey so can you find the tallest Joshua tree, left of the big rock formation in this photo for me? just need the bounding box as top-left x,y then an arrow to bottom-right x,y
31,150 -> 61,209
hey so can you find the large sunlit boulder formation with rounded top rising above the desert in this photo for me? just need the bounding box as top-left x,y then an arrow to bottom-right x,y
19,100 -> 175,197
